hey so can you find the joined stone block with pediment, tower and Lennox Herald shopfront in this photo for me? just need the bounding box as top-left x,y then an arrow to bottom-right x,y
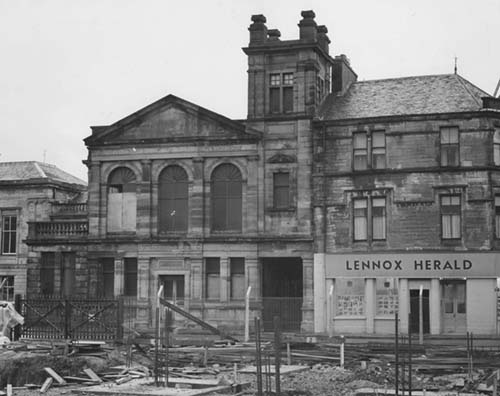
25,11 -> 500,333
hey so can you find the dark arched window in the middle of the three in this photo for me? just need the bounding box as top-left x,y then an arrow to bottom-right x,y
158,166 -> 188,232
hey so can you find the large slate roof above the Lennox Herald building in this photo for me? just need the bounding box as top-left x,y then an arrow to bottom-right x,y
318,74 -> 490,120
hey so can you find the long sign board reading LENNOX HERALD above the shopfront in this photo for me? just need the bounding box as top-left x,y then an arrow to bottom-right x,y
318,252 -> 500,278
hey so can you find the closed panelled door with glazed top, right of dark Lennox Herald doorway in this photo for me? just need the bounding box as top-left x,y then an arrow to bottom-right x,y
441,280 -> 467,333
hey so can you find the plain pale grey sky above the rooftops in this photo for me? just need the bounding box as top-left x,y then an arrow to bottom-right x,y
0,0 -> 500,180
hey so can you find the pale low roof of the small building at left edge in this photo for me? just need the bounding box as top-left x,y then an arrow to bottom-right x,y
0,161 -> 87,186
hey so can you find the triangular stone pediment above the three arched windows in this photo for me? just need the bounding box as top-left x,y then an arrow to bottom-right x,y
85,95 -> 260,144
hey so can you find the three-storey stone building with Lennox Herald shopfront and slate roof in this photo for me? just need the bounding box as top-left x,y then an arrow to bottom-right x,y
313,74 -> 500,334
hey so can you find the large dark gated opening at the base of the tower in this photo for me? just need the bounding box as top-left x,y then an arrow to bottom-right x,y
262,257 -> 303,331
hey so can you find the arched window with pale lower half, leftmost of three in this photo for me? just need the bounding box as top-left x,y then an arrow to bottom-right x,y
108,167 -> 137,232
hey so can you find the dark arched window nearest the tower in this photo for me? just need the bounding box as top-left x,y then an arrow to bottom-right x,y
212,164 -> 242,231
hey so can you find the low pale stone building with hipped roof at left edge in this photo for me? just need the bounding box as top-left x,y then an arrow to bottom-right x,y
0,161 -> 87,301
